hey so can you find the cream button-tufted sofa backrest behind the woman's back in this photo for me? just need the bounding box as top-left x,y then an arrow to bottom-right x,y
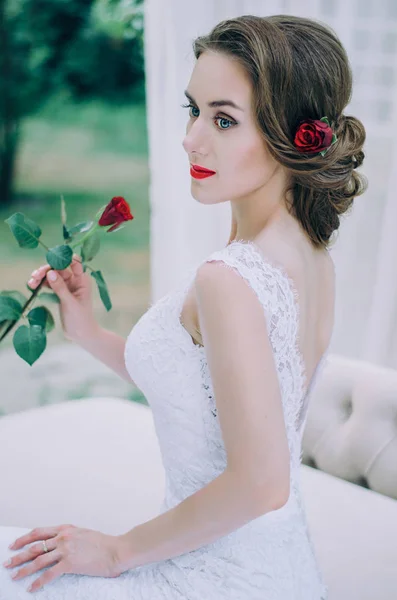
302,355 -> 397,499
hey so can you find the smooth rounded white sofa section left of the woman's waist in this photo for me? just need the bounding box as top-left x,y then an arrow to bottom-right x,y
0,398 -> 165,535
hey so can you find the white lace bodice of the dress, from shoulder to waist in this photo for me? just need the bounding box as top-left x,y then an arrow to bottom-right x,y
125,241 -> 328,492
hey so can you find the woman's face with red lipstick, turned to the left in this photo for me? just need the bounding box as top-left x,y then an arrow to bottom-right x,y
182,52 -> 278,204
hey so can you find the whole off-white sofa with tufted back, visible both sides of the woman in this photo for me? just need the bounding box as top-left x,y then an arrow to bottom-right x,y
0,355 -> 397,600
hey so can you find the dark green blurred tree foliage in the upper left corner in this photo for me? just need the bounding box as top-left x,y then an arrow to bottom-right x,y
0,0 -> 145,205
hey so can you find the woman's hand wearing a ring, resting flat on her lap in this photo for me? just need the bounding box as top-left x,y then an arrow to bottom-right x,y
4,525 -> 123,591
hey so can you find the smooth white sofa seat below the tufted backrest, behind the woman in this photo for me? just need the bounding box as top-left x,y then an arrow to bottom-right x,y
301,465 -> 397,600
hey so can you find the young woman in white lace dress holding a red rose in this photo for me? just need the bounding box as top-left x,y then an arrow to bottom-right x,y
0,15 -> 365,600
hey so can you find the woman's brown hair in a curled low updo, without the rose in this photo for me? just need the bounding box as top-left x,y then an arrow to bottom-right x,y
193,15 -> 367,247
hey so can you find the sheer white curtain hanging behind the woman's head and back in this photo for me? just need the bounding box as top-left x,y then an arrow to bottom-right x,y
145,0 -> 397,367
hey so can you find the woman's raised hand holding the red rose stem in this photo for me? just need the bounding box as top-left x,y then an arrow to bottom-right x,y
28,254 -> 99,342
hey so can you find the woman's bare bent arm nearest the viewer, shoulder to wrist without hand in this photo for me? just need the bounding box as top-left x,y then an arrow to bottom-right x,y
114,262 -> 289,570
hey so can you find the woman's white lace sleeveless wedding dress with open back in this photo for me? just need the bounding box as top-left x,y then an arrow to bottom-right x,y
0,240 -> 328,600
